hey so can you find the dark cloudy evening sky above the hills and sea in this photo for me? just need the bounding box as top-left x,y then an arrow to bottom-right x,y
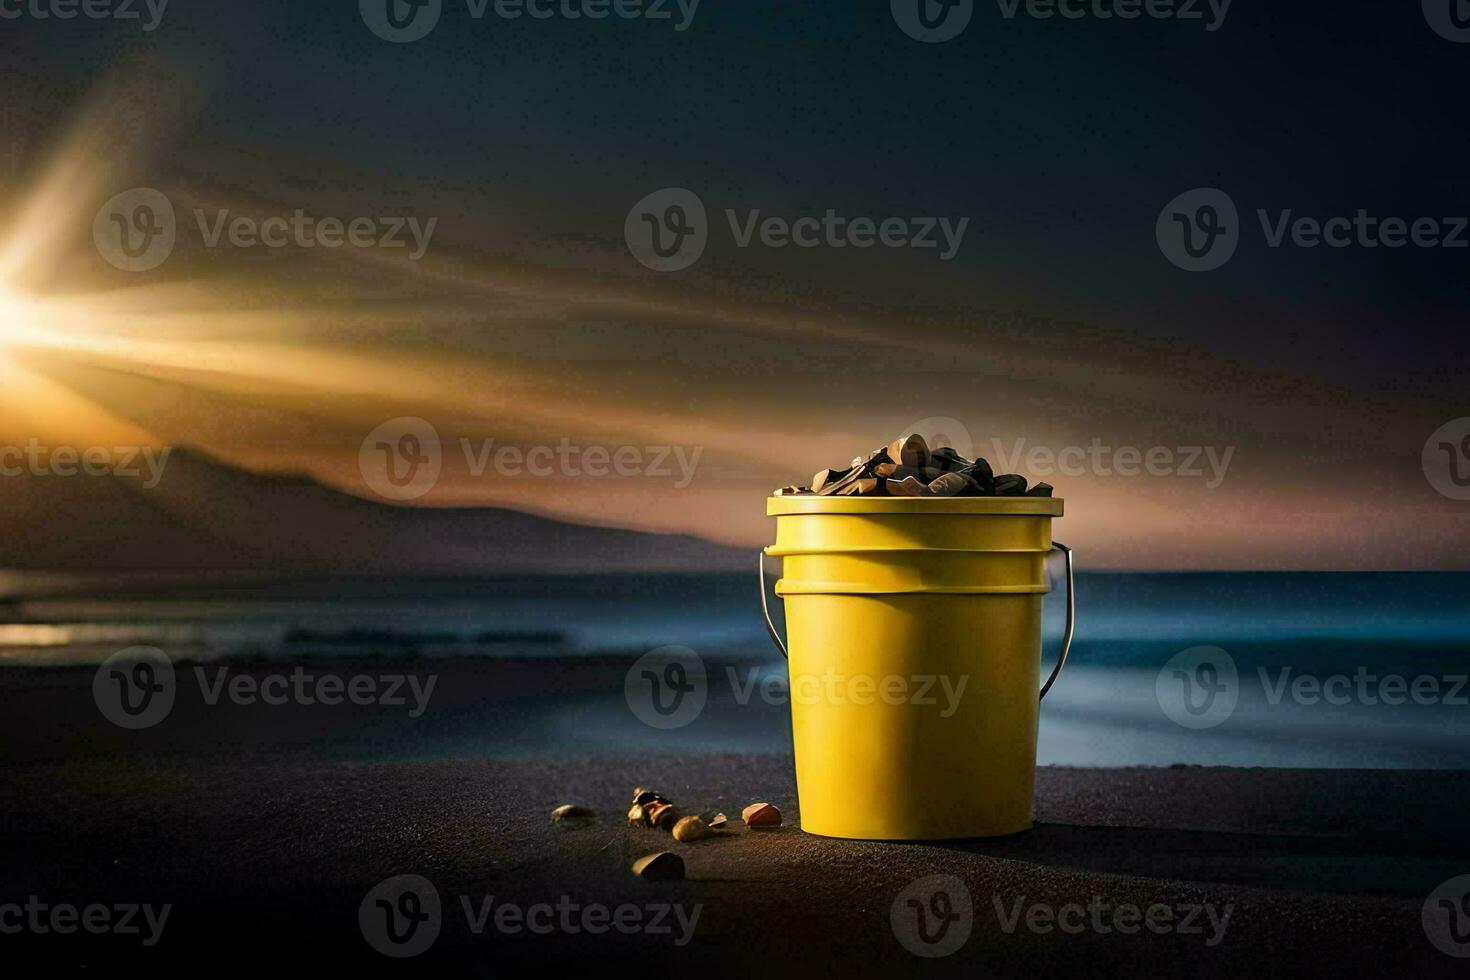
0,0 -> 1470,567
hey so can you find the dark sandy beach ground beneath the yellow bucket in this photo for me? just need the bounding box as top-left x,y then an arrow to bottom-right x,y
0,663 -> 1470,977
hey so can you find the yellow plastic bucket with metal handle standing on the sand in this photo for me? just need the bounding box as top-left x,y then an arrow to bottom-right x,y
760,497 -> 1075,840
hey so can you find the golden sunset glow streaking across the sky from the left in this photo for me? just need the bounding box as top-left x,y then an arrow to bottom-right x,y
0,57 -> 1458,569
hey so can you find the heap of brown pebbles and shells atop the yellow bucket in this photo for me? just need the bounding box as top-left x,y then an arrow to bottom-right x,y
776,433 -> 1051,497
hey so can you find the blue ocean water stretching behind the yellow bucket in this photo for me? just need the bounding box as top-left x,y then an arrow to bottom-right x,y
0,570 -> 1470,768
